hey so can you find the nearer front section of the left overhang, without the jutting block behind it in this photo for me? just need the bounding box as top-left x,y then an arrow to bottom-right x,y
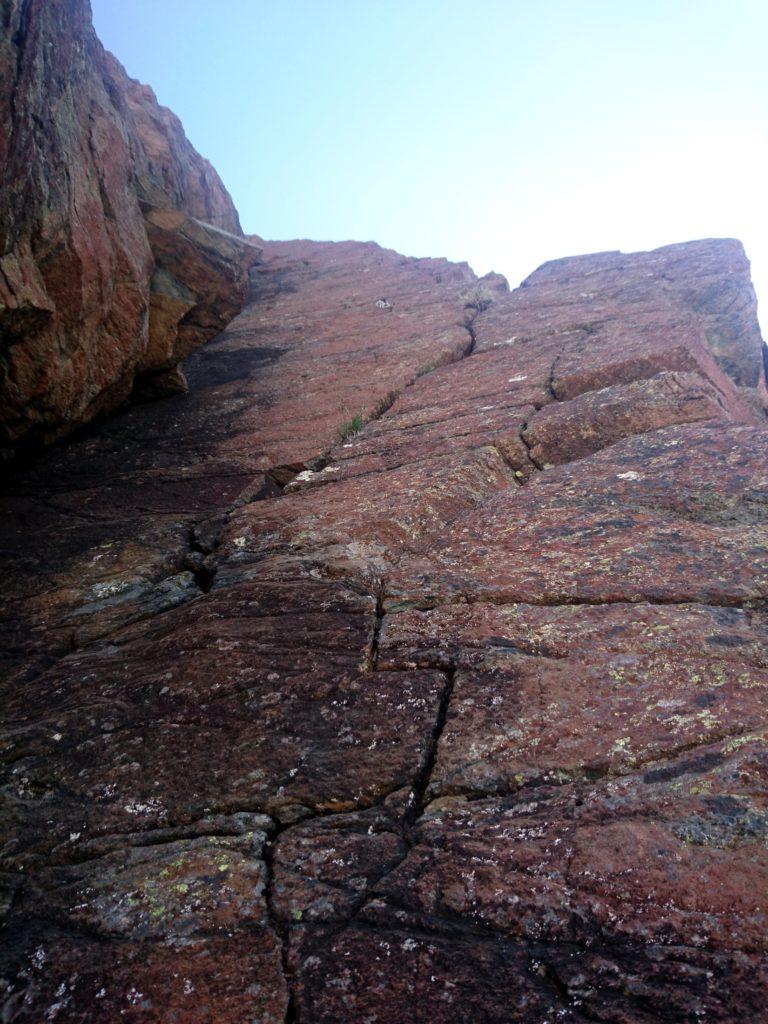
0,0 -> 152,456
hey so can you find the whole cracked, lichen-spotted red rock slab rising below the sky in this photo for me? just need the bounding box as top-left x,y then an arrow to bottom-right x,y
0,228 -> 768,1024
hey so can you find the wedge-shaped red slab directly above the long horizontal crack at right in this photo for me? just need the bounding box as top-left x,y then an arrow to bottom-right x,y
388,423 -> 768,606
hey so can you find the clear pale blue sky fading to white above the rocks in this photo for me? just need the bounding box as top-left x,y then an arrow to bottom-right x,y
92,0 -> 768,324
